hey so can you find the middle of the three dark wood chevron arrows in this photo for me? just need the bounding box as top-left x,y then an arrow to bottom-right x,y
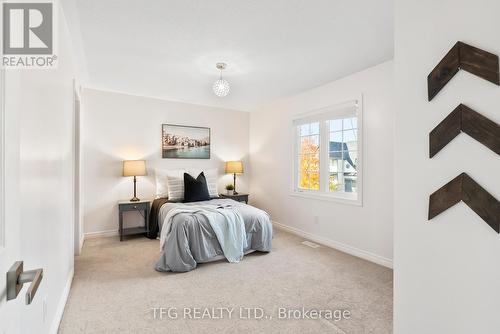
429,104 -> 500,158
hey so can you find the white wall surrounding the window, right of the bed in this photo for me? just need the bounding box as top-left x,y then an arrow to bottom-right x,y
250,62 -> 394,265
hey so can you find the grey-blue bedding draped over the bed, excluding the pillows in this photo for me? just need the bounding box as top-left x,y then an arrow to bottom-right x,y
148,198 -> 273,272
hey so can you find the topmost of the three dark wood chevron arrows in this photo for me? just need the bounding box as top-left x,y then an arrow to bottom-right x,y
427,42 -> 500,101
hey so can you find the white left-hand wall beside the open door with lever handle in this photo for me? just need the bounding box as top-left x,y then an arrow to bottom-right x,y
12,3 -> 77,333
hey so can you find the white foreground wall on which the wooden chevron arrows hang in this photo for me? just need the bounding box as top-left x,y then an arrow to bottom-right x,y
394,0 -> 500,334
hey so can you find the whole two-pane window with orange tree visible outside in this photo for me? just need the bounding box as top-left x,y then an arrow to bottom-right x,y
293,99 -> 362,204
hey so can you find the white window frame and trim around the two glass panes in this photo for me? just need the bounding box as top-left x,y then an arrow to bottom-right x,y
290,94 -> 364,206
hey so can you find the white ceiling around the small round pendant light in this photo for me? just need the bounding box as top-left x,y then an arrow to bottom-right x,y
72,0 -> 393,111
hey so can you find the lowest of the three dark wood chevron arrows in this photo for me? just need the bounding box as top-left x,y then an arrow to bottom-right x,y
429,173 -> 500,233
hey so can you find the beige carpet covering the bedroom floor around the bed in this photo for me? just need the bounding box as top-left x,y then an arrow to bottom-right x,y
59,229 -> 392,334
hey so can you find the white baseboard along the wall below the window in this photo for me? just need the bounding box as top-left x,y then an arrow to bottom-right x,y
273,221 -> 392,269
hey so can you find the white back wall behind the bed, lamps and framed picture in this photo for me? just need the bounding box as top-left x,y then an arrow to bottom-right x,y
82,89 -> 249,234
